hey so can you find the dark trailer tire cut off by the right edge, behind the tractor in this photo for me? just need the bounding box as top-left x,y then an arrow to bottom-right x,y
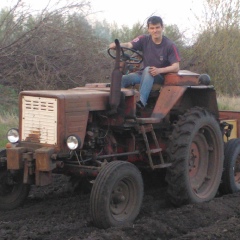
219,138 -> 240,194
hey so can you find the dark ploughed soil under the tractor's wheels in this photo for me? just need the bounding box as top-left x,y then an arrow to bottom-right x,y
0,176 -> 240,240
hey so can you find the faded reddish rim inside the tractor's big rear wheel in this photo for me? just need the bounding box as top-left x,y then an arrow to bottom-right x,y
188,128 -> 218,199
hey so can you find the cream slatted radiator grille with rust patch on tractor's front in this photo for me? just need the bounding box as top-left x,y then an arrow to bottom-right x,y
21,96 -> 57,144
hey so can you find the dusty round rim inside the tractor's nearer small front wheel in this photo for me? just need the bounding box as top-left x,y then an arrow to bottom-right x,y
110,179 -> 136,221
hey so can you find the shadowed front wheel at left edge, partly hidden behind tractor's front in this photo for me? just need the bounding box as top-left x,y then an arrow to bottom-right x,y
0,168 -> 30,210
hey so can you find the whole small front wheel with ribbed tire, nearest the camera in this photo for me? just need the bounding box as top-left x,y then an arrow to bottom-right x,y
90,161 -> 143,228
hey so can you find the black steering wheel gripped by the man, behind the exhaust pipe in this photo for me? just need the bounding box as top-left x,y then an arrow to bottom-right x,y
107,47 -> 143,64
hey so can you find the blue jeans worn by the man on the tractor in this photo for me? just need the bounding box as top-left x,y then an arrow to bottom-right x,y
122,67 -> 164,106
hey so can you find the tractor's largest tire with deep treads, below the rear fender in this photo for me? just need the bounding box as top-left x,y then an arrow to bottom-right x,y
166,107 -> 223,206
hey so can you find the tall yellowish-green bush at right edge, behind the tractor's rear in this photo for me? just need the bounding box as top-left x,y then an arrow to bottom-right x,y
188,0 -> 240,95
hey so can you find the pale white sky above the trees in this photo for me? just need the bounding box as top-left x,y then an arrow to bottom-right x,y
0,0 -> 203,35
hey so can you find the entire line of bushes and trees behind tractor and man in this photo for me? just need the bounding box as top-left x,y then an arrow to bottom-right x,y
0,0 -> 240,95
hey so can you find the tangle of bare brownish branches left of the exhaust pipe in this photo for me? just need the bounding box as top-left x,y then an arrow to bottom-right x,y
0,0 -> 111,91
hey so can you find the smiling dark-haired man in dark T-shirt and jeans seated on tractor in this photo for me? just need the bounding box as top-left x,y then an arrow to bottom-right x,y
109,16 -> 181,108
